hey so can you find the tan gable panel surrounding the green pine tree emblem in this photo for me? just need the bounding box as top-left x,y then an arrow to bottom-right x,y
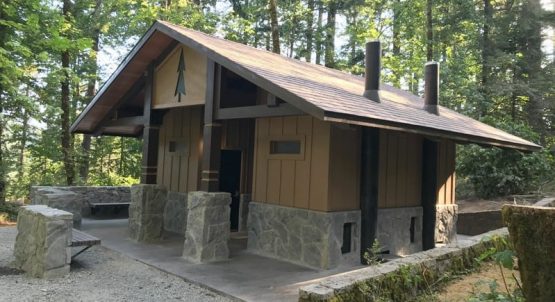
152,46 -> 207,109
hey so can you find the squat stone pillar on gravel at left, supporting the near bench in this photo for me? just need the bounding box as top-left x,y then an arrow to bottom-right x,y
13,205 -> 73,278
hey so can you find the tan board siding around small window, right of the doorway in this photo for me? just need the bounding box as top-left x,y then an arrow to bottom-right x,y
253,116 -> 360,211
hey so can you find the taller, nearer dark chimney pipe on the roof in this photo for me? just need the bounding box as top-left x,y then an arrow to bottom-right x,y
362,40 -> 382,103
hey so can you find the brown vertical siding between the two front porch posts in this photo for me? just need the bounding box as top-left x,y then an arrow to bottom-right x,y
157,106 -> 203,192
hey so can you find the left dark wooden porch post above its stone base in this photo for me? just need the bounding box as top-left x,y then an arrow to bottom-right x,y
141,64 -> 161,184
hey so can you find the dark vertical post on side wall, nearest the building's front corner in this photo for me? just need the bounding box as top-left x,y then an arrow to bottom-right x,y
360,127 -> 380,264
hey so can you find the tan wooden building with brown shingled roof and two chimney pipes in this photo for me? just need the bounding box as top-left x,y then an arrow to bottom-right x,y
72,21 -> 540,268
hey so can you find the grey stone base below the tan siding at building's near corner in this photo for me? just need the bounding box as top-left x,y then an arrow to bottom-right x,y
248,202 -> 360,269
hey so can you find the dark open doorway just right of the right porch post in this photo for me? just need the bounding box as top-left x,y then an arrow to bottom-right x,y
220,150 -> 241,231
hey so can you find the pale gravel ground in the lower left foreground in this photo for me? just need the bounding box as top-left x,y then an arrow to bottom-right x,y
0,227 -> 232,302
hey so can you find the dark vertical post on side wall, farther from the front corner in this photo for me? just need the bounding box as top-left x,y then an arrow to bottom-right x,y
422,139 -> 438,250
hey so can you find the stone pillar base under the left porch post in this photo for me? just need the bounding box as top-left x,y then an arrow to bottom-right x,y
129,184 -> 168,242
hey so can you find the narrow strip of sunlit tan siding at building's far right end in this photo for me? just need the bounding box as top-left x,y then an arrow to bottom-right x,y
437,140 -> 456,204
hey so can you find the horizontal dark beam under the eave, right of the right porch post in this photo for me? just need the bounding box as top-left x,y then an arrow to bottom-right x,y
216,104 -> 306,120
